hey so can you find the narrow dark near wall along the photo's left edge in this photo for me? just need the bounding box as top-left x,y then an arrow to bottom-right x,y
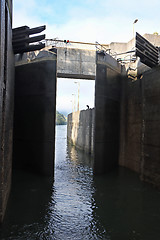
0,0 -> 14,222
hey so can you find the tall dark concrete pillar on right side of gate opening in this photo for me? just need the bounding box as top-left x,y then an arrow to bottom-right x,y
94,53 -> 122,174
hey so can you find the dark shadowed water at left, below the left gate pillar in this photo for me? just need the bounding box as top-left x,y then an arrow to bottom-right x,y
0,170 -> 54,240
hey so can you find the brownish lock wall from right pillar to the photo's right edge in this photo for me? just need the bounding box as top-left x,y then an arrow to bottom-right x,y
119,67 -> 160,188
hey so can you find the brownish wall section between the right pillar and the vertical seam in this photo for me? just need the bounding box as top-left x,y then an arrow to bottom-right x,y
119,75 -> 142,173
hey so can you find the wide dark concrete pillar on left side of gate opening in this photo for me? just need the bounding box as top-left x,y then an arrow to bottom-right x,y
13,57 -> 56,176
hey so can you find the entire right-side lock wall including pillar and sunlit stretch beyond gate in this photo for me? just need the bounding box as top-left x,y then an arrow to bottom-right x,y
67,57 -> 160,188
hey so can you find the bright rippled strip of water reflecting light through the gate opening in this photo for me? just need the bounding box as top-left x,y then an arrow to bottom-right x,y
42,125 -> 107,240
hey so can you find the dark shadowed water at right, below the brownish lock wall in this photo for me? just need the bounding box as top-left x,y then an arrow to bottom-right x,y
94,167 -> 160,240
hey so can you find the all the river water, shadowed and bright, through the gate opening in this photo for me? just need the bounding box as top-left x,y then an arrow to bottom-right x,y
0,126 -> 160,240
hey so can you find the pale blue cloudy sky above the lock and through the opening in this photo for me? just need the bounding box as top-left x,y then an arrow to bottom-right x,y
13,0 -> 160,114
